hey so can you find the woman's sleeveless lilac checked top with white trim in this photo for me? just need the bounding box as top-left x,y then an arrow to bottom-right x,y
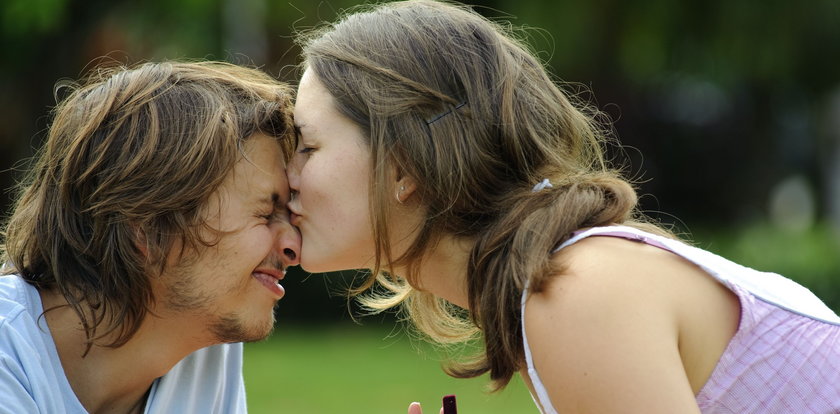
522,226 -> 840,414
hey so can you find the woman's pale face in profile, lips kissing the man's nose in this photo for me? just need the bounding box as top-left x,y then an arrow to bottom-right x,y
287,70 -> 375,272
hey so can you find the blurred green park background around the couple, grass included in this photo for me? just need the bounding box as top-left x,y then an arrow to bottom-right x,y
0,0 -> 840,413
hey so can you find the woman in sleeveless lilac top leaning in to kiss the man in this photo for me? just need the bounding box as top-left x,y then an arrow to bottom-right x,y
289,0 -> 840,413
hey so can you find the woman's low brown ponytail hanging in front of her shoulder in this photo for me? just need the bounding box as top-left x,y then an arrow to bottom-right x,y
456,173 -> 637,389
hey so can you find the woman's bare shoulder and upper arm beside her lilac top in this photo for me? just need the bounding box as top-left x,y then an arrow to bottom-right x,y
525,237 -> 734,412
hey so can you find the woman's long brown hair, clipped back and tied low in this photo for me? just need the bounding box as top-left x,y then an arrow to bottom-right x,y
300,0 -> 668,389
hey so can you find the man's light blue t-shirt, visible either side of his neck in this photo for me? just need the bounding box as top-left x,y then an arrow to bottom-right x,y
0,276 -> 247,414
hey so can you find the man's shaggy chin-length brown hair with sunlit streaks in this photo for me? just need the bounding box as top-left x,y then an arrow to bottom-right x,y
0,62 -> 293,349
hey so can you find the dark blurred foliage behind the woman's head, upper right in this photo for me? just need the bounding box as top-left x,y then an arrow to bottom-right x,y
476,0 -> 840,225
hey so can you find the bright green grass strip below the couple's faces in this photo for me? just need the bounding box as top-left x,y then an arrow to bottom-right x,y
244,321 -> 538,414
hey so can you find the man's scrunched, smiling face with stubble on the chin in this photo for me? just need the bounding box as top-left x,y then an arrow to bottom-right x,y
161,134 -> 300,342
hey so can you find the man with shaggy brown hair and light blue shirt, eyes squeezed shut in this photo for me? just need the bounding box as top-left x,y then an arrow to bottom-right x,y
0,62 -> 300,413
